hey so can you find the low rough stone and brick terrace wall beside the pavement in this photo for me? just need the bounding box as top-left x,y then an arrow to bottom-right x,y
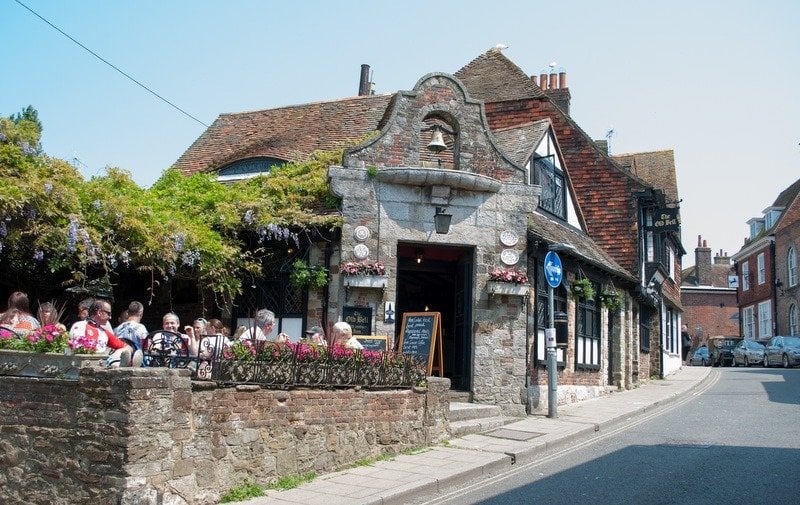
0,368 -> 449,504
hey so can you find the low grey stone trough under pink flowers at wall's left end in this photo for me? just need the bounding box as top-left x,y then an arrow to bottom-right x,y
0,349 -> 103,379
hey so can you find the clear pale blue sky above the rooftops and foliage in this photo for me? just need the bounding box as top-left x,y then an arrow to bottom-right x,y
0,0 -> 800,267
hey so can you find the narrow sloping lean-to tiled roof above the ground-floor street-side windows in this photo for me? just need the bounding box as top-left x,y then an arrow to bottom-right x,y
528,212 -> 636,282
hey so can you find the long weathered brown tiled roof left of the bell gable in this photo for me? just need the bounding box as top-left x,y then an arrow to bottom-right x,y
175,95 -> 394,175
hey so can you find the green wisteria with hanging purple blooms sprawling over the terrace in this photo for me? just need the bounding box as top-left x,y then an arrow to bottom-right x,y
0,107 -> 342,306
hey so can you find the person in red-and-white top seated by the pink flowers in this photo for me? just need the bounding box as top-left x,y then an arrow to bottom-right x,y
69,299 -> 133,368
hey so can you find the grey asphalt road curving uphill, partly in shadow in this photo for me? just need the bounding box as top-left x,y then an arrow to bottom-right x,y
419,367 -> 800,505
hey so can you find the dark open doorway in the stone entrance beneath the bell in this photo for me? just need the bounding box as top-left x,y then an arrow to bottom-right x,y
395,243 -> 474,391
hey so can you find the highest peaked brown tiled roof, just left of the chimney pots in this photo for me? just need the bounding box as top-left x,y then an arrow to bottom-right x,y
455,49 -> 544,102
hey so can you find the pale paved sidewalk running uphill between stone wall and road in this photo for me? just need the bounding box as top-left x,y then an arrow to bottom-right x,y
238,366 -> 713,505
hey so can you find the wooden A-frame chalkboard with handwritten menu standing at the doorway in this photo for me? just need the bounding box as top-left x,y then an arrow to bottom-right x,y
397,312 -> 444,377
